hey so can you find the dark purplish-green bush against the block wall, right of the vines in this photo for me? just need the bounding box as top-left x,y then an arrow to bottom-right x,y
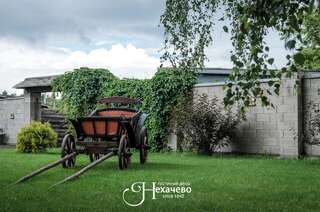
173,95 -> 240,155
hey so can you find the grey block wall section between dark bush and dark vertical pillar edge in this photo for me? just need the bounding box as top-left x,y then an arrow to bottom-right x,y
194,77 -> 302,157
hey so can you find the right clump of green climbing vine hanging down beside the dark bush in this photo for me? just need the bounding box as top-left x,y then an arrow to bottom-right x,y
145,68 -> 196,151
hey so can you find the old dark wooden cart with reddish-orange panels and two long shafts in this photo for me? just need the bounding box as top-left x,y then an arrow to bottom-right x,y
15,96 -> 149,186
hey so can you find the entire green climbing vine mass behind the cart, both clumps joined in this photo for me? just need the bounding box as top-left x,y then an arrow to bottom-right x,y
52,68 -> 196,151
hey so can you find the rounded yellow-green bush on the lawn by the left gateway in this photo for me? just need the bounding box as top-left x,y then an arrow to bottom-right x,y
16,121 -> 58,152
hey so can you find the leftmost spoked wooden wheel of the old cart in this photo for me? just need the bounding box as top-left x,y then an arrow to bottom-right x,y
61,134 -> 77,168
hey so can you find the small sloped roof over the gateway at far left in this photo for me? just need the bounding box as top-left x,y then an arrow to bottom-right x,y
13,75 -> 59,89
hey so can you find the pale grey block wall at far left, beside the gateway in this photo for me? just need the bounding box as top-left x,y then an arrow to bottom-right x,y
0,97 -> 26,144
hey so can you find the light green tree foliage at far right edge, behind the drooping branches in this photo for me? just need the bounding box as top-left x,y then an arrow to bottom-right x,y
300,10 -> 320,70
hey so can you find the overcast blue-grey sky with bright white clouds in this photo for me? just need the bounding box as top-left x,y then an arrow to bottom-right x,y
0,0 -> 286,92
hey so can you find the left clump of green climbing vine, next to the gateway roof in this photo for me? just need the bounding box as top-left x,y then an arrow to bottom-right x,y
52,68 -> 117,118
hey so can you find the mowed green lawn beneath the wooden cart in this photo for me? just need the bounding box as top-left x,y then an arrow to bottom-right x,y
0,149 -> 320,212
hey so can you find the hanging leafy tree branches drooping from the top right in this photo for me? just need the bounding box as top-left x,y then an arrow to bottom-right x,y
161,0 -> 319,111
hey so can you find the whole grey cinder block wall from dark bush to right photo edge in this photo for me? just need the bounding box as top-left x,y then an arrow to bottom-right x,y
188,73 -> 320,157
